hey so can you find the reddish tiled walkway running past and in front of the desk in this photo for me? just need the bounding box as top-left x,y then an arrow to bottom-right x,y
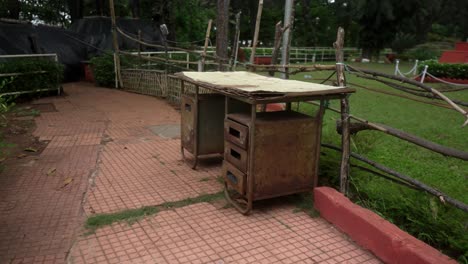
0,83 -> 379,263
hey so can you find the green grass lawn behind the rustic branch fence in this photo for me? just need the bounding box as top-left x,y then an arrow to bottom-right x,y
282,63 -> 468,263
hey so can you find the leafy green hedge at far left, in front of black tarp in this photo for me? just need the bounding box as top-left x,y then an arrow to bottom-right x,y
0,58 -> 63,93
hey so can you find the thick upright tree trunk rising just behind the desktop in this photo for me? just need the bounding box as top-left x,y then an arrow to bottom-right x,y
216,0 -> 229,71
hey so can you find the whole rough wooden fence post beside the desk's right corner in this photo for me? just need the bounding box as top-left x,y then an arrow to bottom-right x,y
333,27 -> 350,194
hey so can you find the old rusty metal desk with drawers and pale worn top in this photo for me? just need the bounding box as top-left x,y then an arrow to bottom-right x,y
177,72 -> 354,214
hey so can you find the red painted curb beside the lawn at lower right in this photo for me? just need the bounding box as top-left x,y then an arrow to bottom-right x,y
314,187 -> 457,264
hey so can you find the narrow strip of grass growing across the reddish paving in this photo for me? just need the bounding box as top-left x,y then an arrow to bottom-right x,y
85,192 -> 224,234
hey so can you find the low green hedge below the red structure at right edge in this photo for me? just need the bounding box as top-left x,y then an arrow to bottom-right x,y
418,60 -> 468,79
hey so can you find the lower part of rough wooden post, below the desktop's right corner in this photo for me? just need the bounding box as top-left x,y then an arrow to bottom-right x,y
340,96 -> 350,195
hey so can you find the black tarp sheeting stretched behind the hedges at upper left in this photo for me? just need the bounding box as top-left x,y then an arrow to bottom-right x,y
0,17 -> 162,81
